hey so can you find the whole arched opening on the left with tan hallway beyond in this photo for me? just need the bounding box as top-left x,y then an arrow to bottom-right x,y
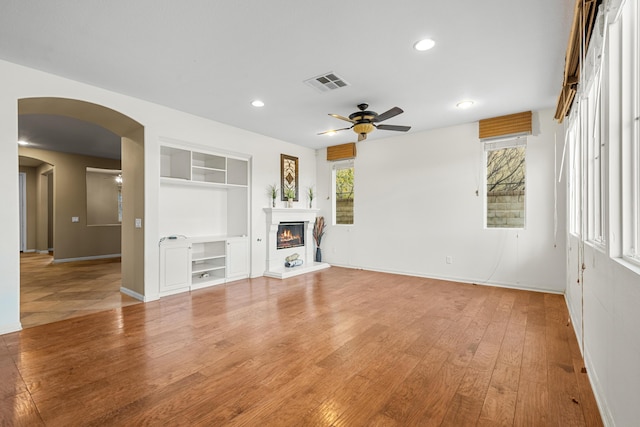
18,98 -> 144,327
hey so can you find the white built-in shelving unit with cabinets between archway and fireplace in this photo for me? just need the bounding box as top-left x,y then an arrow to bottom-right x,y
160,145 -> 249,296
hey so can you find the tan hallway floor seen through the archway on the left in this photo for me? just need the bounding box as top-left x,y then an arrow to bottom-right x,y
20,253 -> 140,328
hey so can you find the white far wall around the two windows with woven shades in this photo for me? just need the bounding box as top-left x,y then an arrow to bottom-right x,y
317,110 -> 565,293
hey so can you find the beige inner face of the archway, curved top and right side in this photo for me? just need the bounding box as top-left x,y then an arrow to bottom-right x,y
16,97 -> 144,316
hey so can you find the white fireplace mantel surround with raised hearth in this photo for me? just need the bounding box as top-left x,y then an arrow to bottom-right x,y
264,208 -> 330,279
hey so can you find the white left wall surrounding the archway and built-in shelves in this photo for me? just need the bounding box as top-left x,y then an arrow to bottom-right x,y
0,61 -> 316,333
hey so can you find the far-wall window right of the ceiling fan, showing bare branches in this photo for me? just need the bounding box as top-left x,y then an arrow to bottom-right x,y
485,138 -> 526,228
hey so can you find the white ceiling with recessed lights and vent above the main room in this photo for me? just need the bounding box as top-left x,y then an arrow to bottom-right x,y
0,0 -> 574,157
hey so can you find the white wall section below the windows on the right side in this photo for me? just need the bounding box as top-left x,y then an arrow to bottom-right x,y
566,236 -> 640,426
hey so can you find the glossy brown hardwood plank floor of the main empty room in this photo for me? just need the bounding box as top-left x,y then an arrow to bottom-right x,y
0,267 -> 602,426
